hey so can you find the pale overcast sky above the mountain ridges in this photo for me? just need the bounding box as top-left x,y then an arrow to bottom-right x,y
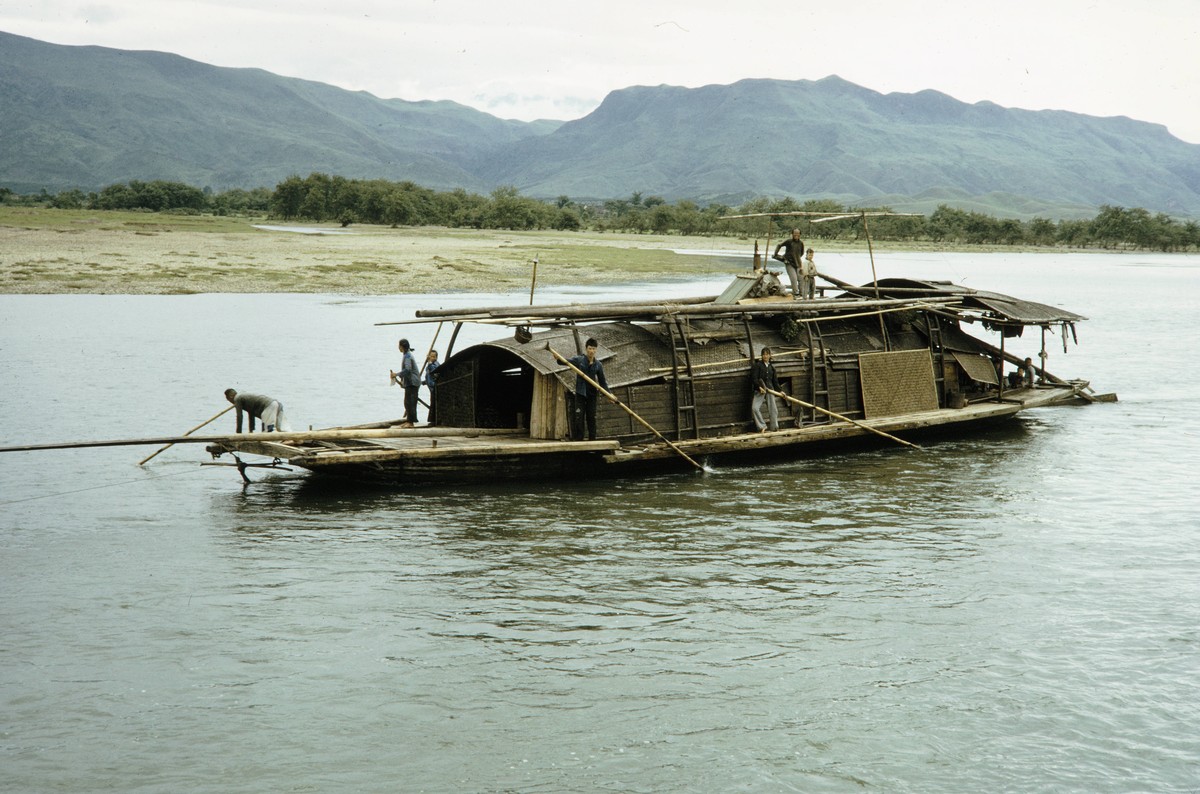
7,0 -> 1200,143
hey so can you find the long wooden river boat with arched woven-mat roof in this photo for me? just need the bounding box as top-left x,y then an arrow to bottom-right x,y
194,263 -> 1115,487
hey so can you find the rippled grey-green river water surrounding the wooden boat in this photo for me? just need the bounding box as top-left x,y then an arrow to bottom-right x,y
0,254 -> 1200,793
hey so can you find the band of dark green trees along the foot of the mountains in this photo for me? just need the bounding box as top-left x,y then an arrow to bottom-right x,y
0,173 -> 1200,252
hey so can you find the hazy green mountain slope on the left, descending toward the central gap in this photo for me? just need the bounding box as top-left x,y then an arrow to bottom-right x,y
0,32 -> 558,192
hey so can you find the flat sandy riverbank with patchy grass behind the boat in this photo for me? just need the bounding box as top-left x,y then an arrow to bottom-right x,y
0,206 -> 1065,295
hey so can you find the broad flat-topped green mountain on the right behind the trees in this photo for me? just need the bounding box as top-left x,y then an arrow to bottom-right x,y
473,77 -> 1200,215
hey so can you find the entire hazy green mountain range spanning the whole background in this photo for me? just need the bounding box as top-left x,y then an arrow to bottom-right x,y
0,32 -> 1200,217
